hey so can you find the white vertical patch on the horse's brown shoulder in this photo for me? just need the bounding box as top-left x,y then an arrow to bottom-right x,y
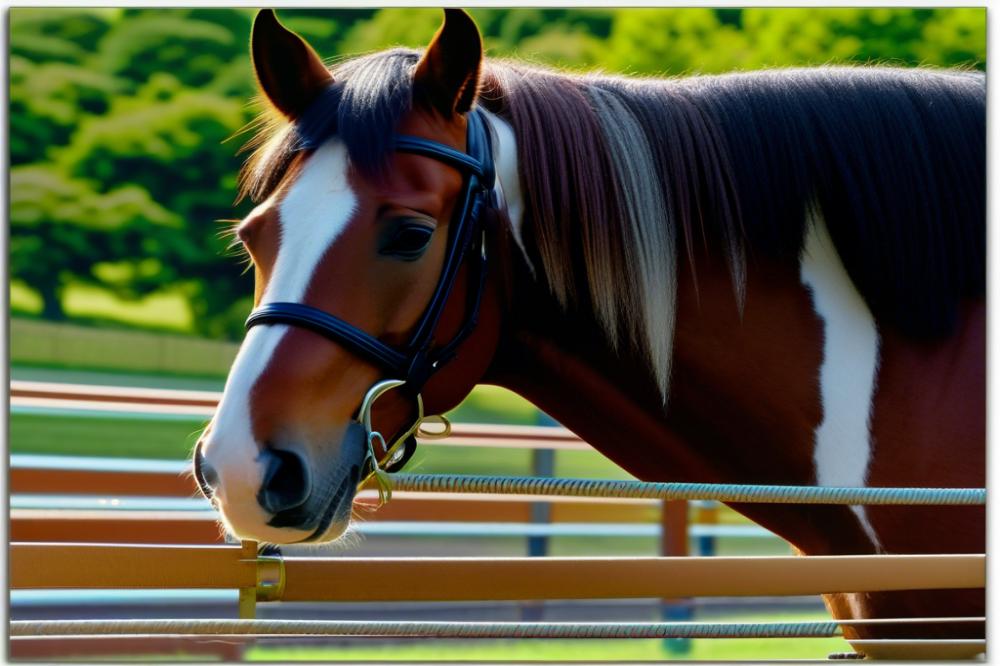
801,214 -> 881,550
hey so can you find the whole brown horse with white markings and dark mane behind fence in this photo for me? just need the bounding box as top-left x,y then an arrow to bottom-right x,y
194,9 -> 986,638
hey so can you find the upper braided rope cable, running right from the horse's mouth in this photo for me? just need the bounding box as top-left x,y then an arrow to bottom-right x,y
389,474 -> 986,506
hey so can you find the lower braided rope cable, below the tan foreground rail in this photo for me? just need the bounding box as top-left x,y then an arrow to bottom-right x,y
10,617 -> 985,639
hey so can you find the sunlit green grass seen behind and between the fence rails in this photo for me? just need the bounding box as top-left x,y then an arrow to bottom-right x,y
9,292 -> 812,662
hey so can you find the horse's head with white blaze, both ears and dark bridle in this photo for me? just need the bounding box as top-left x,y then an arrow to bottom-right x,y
194,10 -> 499,543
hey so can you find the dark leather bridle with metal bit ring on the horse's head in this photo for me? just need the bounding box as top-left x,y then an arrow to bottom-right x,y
246,109 -> 496,487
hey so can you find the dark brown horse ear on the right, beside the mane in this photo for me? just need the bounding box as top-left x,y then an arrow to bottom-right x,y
413,9 -> 483,117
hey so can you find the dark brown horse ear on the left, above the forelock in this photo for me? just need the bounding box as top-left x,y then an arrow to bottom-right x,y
250,9 -> 333,120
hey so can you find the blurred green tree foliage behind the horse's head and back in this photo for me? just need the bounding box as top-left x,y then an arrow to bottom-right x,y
9,6 -> 986,336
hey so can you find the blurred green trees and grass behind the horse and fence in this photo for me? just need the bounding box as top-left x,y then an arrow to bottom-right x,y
9,8 -> 986,660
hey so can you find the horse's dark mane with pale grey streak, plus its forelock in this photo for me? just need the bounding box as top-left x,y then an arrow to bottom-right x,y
241,49 -> 986,400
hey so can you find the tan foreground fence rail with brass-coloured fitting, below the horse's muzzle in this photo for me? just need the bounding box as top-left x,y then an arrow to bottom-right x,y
10,543 -> 986,601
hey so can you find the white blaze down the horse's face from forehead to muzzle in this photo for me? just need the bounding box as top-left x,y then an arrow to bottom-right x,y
202,139 -> 357,543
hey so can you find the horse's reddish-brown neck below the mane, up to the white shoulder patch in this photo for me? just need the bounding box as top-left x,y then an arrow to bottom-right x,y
486,241 -> 871,553
